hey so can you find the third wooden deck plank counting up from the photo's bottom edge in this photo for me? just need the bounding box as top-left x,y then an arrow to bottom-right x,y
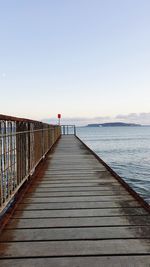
0,226 -> 150,242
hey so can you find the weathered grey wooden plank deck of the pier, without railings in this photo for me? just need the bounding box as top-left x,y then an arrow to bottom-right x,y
0,135 -> 150,267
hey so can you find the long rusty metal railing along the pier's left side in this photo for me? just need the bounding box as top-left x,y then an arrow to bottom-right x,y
0,115 -> 61,212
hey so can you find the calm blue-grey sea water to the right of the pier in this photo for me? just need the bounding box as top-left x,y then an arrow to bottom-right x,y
77,127 -> 150,203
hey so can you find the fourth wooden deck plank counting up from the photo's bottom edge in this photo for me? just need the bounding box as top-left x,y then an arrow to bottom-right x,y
6,215 -> 150,229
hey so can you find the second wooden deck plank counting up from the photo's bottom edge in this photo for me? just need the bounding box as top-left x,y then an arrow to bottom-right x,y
0,239 -> 150,258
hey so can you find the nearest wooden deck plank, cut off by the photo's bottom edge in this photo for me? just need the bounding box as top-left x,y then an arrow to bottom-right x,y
0,255 -> 150,267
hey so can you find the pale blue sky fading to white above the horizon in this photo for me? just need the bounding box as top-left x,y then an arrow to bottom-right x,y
0,0 -> 150,124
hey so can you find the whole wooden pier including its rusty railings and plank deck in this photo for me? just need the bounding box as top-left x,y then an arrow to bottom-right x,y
0,115 -> 150,267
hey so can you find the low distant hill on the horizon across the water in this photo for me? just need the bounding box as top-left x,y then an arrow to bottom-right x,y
86,122 -> 142,127
